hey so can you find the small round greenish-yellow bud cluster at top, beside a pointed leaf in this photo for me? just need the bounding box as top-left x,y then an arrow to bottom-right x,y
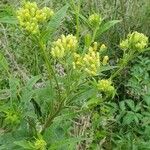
88,13 -> 102,27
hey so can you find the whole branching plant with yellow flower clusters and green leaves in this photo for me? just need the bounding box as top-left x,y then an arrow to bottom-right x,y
0,2 -> 148,150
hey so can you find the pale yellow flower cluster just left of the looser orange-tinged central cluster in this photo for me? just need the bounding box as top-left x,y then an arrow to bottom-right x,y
51,34 -> 78,58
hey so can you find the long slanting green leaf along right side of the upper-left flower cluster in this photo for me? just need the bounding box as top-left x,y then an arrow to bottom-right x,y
42,4 -> 69,41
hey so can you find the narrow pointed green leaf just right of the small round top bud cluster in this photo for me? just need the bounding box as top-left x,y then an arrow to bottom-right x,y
96,20 -> 121,38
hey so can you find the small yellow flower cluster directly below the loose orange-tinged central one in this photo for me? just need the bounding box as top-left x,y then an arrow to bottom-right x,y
97,79 -> 115,94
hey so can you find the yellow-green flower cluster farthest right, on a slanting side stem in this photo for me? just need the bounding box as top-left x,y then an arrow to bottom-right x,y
120,31 -> 148,51
